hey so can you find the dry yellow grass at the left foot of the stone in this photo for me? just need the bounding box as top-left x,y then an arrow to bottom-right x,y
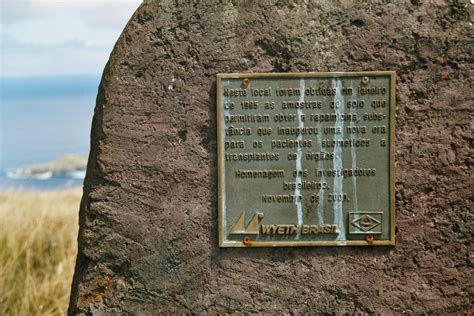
0,189 -> 81,315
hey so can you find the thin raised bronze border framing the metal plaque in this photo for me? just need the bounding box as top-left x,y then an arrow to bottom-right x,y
216,70 -> 397,248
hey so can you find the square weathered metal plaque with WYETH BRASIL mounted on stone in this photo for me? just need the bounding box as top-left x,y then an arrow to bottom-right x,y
217,71 -> 395,247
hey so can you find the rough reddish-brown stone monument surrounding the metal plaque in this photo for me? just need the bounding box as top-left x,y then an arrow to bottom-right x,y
69,0 -> 474,315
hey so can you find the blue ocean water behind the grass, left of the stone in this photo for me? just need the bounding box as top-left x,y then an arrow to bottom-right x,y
0,75 -> 100,190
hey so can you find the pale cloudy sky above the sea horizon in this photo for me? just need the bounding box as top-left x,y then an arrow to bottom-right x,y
0,0 -> 142,77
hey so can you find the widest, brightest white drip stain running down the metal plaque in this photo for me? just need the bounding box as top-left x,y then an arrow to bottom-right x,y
332,79 -> 346,240
